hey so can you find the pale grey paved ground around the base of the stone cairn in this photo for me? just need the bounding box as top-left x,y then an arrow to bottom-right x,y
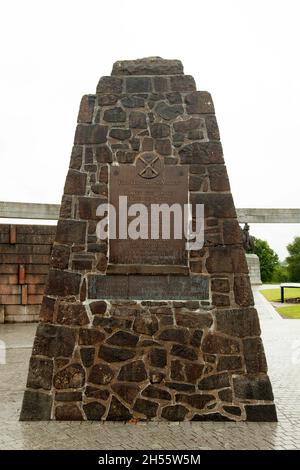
0,289 -> 300,450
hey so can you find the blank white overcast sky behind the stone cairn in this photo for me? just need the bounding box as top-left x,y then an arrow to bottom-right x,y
0,0 -> 300,258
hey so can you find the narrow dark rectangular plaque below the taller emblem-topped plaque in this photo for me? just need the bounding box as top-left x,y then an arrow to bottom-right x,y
88,274 -> 209,300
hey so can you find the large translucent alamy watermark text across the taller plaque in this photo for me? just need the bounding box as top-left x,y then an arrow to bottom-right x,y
96,196 -> 204,250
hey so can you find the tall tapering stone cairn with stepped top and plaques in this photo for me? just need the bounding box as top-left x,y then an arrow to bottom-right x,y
21,57 -> 276,421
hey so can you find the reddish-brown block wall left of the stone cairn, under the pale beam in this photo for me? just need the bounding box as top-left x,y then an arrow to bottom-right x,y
0,224 -> 56,323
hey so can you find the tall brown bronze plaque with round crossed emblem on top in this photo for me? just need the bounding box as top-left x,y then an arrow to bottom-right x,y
109,152 -> 188,266
